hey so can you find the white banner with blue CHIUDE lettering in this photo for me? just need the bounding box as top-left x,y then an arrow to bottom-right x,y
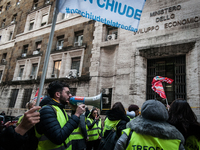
58,0 -> 146,32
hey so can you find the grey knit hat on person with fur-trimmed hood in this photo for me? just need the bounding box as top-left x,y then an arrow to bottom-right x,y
141,100 -> 169,121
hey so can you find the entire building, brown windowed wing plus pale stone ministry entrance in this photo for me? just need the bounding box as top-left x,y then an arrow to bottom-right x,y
0,0 -> 200,117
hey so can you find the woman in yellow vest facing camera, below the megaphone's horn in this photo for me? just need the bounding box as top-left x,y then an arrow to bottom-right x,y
86,108 -> 102,150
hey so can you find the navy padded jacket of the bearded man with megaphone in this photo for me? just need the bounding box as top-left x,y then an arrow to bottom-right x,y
36,97 -> 80,145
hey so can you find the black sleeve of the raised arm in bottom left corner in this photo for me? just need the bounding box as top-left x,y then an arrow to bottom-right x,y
0,126 -> 28,150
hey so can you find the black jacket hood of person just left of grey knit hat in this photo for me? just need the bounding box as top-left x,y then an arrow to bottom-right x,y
106,109 -> 130,122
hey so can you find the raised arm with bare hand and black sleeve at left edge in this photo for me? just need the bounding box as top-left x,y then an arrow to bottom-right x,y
0,106 -> 41,150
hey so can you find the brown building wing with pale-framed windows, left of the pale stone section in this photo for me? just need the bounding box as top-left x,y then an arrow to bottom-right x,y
0,0 -> 95,115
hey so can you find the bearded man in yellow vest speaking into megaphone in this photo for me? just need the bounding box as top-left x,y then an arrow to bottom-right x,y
35,81 -> 85,150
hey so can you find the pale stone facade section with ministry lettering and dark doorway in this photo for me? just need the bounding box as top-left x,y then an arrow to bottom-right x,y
90,0 -> 200,117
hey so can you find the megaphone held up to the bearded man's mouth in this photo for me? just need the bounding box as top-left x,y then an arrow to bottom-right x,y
69,93 -> 102,110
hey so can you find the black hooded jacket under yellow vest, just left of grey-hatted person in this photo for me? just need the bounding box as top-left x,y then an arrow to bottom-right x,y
104,109 -> 130,137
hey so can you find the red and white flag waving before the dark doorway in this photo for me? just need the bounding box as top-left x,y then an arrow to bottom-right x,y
151,76 -> 174,99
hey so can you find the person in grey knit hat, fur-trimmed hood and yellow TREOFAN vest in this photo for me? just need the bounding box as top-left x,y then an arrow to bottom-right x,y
114,100 -> 184,150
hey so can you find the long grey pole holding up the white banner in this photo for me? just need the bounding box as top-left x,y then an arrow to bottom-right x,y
36,0 -> 59,106
